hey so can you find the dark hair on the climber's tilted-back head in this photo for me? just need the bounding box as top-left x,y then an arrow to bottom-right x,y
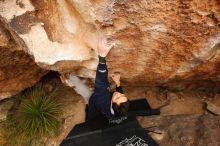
112,100 -> 130,116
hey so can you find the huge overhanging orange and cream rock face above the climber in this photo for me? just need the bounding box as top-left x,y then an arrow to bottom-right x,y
0,0 -> 220,88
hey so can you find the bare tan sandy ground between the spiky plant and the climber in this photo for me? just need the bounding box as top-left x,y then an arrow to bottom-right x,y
44,80 -> 85,146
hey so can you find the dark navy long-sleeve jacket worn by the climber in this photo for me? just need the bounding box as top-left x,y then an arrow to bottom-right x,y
88,56 -> 127,124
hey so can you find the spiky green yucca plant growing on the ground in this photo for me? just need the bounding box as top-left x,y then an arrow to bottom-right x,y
7,85 -> 61,143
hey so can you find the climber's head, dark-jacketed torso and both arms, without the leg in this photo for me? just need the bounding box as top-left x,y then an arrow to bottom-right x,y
88,38 -> 129,124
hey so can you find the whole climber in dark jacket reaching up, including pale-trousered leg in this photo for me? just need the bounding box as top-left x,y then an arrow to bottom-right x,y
60,38 -> 129,124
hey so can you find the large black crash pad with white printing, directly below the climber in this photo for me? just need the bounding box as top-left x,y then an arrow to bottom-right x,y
60,118 -> 158,146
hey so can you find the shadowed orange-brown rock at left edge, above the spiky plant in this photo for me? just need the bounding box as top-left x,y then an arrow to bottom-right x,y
0,18 -> 47,100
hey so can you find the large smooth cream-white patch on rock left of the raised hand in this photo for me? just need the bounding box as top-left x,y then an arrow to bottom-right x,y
20,24 -> 90,65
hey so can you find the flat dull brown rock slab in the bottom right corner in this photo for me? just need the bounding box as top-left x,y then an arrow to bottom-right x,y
139,115 -> 220,146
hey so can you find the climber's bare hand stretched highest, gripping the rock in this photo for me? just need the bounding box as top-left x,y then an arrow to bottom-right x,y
98,36 -> 114,57
